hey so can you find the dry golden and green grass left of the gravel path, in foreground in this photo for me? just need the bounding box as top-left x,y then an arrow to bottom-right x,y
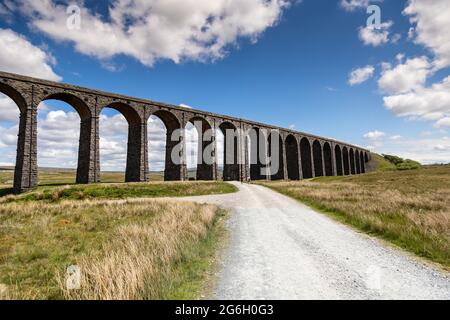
0,199 -> 223,299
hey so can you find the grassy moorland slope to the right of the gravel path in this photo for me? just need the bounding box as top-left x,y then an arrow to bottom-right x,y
256,164 -> 450,268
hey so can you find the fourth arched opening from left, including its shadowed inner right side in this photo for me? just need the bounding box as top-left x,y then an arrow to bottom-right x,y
152,110 -> 182,181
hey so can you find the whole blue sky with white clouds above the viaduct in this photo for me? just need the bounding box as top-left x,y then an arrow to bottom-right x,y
0,0 -> 450,171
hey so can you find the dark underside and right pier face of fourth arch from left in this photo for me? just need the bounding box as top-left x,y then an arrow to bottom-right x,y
150,110 -> 183,181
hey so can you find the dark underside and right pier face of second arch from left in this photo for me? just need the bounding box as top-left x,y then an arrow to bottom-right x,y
38,92 -> 95,184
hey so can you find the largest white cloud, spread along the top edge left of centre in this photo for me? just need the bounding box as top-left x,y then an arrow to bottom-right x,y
20,0 -> 290,66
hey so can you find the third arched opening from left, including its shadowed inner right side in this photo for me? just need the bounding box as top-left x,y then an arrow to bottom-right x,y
99,103 -> 144,182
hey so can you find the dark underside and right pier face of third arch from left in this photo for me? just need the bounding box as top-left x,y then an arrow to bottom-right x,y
98,102 -> 144,182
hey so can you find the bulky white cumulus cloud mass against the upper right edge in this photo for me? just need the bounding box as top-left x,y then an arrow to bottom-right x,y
378,0 -> 450,128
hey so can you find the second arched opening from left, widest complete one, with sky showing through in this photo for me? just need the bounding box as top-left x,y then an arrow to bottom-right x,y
37,92 -> 95,184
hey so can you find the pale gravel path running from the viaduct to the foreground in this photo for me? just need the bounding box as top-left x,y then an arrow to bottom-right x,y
184,183 -> 450,300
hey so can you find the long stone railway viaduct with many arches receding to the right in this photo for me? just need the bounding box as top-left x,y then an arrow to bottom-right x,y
0,72 -> 371,193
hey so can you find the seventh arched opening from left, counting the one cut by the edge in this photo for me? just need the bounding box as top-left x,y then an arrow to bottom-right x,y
248,127 -> 268,180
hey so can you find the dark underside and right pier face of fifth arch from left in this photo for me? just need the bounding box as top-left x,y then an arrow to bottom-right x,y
186,116 -> 215,180
